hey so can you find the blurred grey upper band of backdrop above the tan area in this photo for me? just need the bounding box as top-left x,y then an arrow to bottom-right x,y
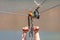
0,0 -> 60,12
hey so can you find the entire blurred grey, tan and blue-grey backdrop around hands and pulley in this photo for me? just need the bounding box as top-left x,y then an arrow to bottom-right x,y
0,0 -> 60,40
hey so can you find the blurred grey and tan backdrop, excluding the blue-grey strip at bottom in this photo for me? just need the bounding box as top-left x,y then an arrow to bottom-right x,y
0,0 -> 60,32
